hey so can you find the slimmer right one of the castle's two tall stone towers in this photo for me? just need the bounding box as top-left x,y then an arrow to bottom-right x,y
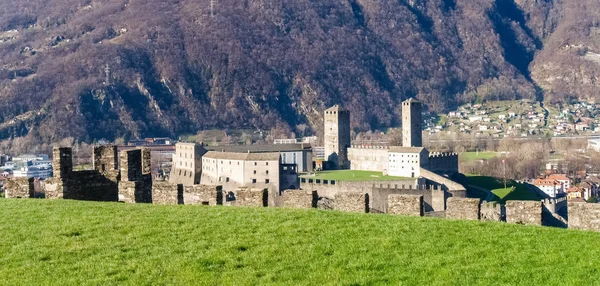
402,98 -> 423,147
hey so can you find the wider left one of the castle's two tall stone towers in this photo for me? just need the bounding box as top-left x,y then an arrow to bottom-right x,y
323,105 -> 350,169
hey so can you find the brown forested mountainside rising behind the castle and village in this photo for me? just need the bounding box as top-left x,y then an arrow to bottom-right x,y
0,0 -> 600,142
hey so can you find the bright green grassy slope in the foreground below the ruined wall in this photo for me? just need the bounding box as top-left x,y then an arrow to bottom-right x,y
0,200 -> 600,285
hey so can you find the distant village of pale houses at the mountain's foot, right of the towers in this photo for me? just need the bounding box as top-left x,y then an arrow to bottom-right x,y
425,99 -> 600,138
